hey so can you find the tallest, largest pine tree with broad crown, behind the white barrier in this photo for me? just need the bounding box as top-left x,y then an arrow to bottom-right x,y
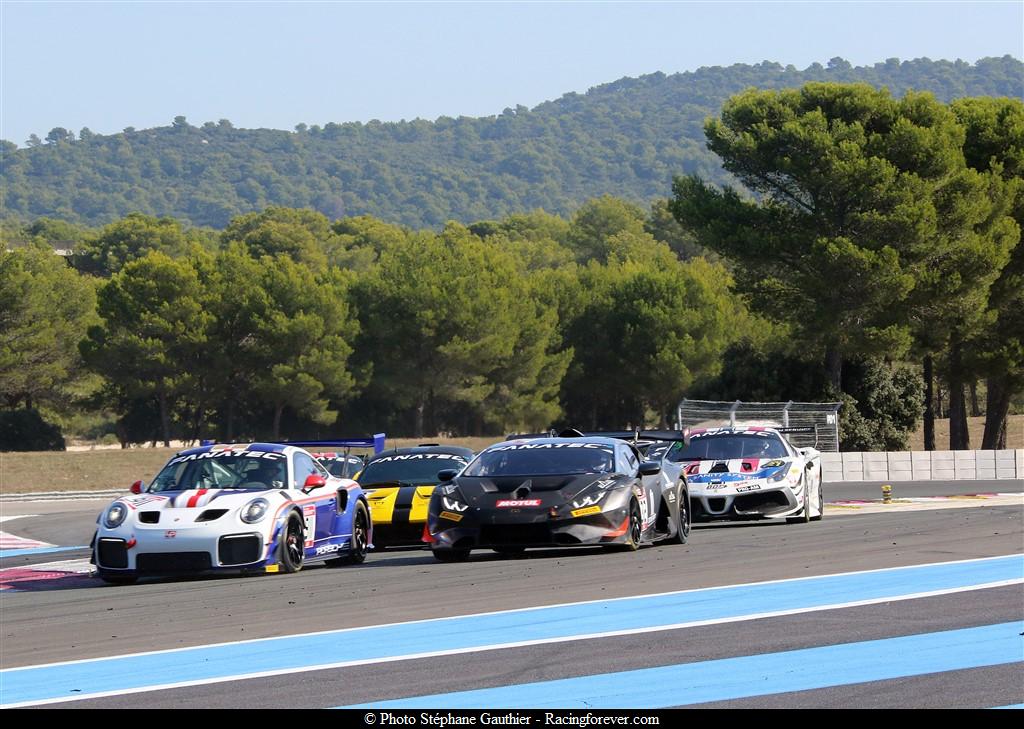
672,83 -> 1012,444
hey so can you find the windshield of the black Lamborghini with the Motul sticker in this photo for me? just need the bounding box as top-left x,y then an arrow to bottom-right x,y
463,443 -> 614,476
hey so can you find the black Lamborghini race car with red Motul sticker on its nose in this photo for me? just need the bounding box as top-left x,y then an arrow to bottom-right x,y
423,431 -> 690,562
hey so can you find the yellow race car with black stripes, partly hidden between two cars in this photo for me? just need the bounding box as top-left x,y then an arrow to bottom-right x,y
353,445 -> 473,549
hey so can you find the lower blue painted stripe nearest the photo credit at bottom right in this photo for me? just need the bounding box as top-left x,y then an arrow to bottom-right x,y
348,623 -> 1024,709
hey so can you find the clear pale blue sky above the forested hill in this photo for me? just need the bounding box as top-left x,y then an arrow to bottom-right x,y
0,0 -> 1024,144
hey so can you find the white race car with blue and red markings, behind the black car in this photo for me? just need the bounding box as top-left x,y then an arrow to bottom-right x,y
665,426 -> 824,523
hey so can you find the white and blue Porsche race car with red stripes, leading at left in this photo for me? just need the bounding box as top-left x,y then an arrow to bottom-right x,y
93,443 -> 373,584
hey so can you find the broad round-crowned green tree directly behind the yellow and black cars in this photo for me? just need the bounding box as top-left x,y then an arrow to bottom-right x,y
356,224 -> 567,436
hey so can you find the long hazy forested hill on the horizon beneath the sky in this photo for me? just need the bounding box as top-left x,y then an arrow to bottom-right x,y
0,55 -> 1024,227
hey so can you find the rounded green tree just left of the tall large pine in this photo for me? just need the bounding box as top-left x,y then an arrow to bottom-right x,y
564,254 -> 756,428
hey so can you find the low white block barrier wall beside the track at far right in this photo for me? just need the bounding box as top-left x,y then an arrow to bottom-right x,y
821,448 -> 1024,481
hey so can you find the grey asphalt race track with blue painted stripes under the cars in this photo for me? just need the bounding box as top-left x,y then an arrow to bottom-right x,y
0,481 -> 1024,710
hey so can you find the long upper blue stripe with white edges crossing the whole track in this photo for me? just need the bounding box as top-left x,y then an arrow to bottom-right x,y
0,555 -> 1024,704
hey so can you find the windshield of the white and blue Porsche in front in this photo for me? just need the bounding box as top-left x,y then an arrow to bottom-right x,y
150,451 -> 288,491
